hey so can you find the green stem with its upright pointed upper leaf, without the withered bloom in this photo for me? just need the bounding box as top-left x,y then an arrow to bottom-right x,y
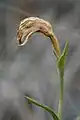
57,42 -> 68,120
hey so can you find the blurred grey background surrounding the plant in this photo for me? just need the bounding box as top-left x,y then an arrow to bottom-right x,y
0,0 -> 80,120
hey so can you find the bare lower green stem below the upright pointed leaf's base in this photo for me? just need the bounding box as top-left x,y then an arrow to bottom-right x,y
58,73 -> 64,120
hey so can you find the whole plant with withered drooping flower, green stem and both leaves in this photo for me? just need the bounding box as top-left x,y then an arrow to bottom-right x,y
17,17 -> 68,120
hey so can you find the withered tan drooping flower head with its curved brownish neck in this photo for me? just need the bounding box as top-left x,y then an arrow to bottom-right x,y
17,17 -> 60,57
